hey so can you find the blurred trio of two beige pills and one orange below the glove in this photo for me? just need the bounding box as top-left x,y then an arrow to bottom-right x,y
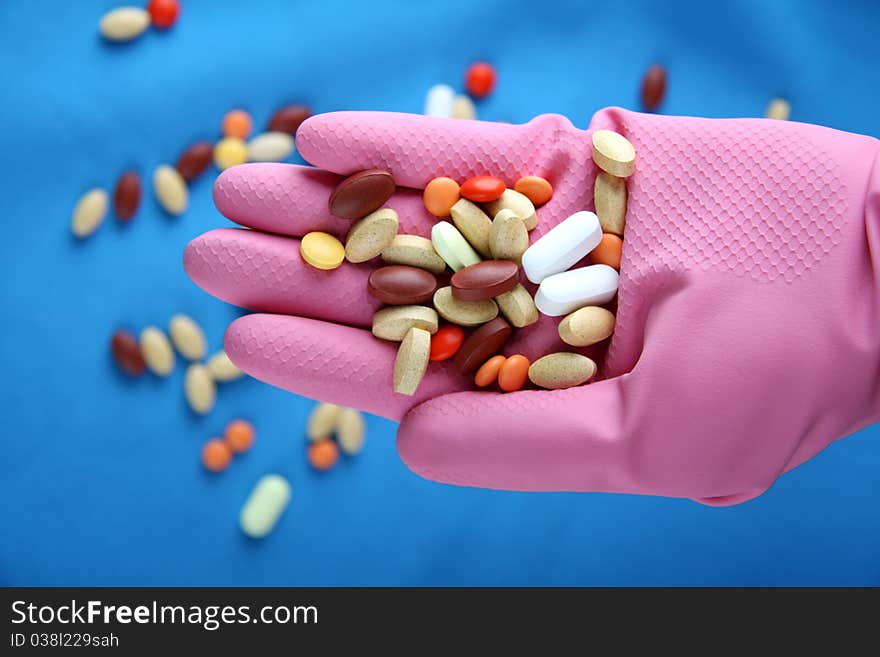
306,402 -> 366,471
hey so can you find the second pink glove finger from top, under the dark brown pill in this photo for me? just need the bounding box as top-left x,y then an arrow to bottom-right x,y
214,162 -> 436,239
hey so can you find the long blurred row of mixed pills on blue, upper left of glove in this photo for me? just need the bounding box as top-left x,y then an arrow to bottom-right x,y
71,105 -> 311,239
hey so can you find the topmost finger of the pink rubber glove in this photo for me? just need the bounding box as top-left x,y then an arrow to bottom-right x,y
296,112 -> 590,189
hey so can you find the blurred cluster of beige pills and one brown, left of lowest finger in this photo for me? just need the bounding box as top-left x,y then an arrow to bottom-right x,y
110,315 -> 244,415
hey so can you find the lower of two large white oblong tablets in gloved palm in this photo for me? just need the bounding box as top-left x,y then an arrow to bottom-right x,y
535,265 -> 618,317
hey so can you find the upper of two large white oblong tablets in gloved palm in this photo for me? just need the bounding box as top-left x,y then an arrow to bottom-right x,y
522,210 -> 602,283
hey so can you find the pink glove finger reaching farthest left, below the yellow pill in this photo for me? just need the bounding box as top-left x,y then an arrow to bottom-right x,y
183,228 -> 381,327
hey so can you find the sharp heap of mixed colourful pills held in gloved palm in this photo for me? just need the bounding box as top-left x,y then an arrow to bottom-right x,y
300,130 -> 635,394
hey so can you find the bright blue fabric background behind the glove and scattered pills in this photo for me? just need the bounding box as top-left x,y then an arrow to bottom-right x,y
0,0 -> 880,585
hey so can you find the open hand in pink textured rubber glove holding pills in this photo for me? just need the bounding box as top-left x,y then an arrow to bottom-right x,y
184,109 -> 880,505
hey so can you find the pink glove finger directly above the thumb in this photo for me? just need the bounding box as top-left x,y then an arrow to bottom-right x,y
224,315 -> 465,420
